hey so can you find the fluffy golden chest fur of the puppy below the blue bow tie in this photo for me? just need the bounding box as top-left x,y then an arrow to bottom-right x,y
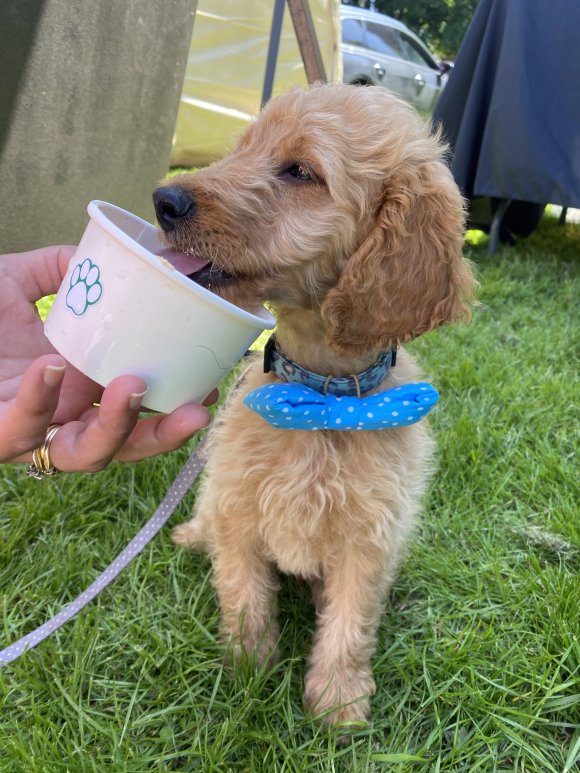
216,413 -> 394,577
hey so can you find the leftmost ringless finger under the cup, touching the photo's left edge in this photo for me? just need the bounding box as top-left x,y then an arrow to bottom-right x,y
0,354 -> 66,462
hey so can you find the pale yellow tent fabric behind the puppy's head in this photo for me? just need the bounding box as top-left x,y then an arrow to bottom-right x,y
171,0 -> 342,166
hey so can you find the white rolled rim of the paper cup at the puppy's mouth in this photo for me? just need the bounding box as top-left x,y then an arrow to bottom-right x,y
87,199 -> 276,330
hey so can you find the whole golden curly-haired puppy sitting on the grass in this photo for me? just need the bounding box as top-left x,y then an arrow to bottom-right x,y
155,85 -> 475,723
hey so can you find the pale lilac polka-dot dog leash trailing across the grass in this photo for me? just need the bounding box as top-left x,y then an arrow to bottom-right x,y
0,437 -> 205,666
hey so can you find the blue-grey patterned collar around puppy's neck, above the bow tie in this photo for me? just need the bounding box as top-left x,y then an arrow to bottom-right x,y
264,336 -> 397,397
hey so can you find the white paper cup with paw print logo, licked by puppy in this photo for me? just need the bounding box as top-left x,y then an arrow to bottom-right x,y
44,201 -> 275,413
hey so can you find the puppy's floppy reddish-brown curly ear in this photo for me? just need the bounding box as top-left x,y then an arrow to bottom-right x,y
322,160 -> 476,354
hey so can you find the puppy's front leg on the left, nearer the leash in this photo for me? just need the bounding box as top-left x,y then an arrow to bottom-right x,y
213,534 -> 278,665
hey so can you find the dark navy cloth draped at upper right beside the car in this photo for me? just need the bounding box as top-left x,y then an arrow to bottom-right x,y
433,0 -> 580,207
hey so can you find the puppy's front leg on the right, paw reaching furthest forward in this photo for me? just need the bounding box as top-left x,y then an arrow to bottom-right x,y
304,551 -> 386,724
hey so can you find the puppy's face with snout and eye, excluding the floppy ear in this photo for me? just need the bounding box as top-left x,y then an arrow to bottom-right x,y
155,89 -> 380,307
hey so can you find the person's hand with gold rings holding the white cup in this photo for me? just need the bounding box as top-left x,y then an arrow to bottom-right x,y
0,247 -> 209,472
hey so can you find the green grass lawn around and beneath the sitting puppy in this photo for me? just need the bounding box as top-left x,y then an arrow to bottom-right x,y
0,211 -> 580,773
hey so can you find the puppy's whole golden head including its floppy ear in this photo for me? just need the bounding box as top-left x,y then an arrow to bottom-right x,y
154,85 -> 471,351
